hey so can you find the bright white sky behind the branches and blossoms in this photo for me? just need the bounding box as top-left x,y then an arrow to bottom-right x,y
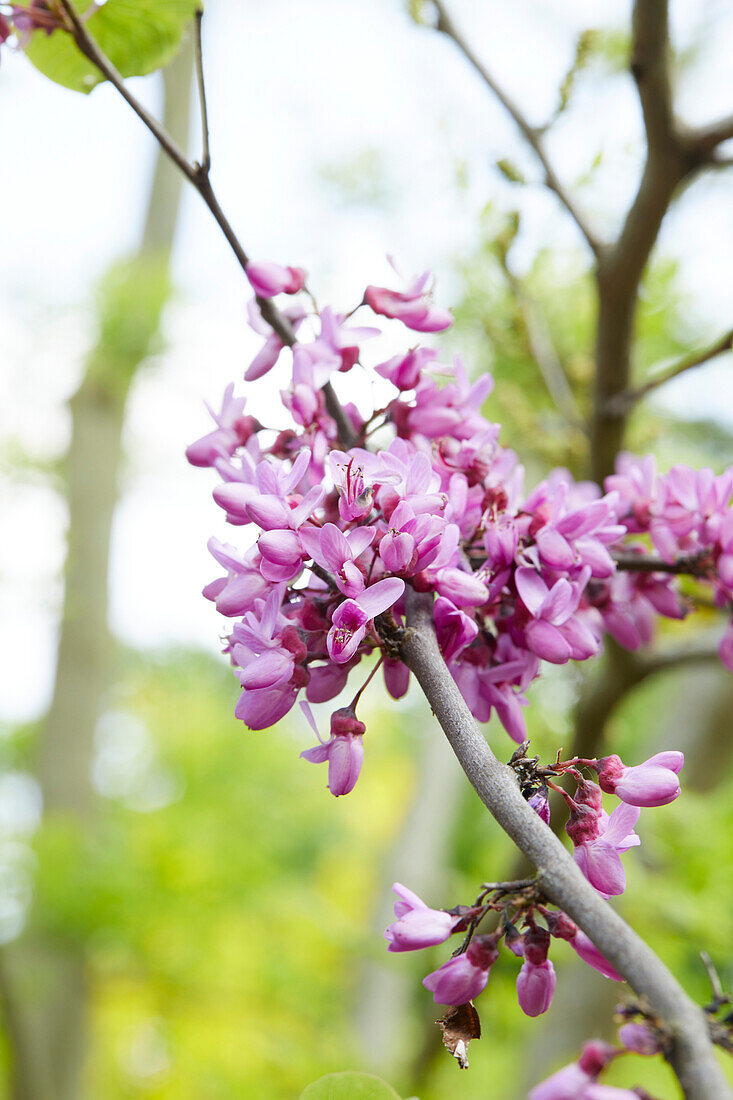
0,0 -> 733,721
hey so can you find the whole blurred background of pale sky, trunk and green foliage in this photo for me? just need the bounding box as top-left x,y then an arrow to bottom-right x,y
0,0 -> 733,1100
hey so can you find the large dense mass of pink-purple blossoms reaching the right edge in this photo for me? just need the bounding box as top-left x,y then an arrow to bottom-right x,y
187,255 -> 733,800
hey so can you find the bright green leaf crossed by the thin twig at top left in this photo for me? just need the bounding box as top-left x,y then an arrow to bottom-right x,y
25,0 -> 198,92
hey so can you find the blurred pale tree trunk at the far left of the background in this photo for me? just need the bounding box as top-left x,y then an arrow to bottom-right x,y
0,44 -> 193,1100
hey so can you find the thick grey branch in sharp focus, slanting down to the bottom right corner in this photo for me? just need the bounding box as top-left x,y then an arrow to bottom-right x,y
401,590 -> 732,1100
